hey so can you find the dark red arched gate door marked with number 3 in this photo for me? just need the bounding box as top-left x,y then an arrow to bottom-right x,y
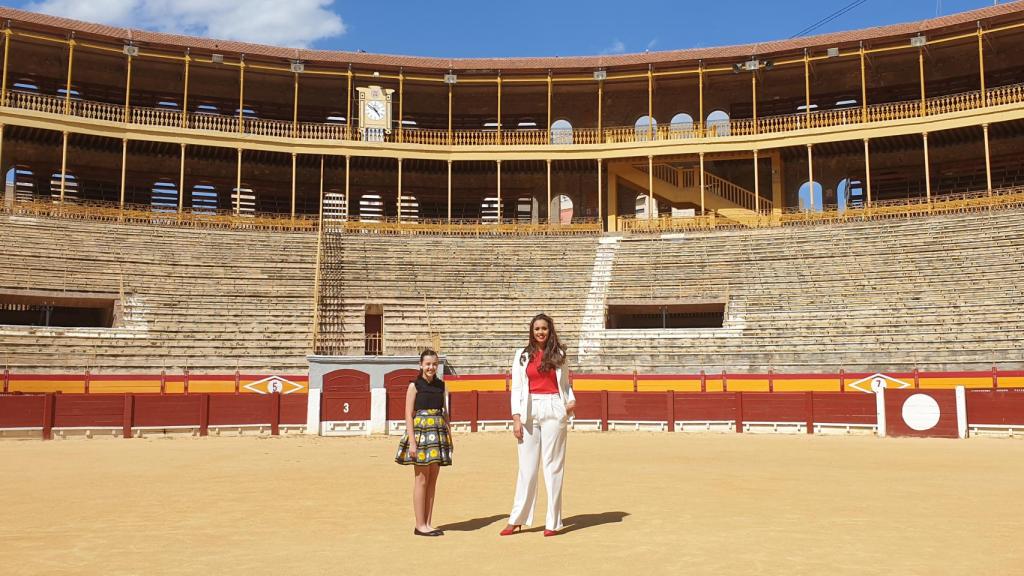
321,369 -> 371,436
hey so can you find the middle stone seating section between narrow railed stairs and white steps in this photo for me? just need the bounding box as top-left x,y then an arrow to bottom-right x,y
319,234 -> 597,373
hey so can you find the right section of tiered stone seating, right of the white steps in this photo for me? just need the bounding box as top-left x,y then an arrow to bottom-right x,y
593,211 -> 1024,372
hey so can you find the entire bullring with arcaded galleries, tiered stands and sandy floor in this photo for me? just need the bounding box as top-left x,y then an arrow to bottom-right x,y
0,2 -> 1024,574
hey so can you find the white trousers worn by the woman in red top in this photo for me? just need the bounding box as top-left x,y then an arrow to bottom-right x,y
509,394 -> 568,530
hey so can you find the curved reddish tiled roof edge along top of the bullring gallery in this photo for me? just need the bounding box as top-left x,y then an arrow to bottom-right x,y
0,0 -> 1024,72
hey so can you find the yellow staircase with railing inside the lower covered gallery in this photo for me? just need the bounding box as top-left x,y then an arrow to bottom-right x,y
608,164 -> 772,221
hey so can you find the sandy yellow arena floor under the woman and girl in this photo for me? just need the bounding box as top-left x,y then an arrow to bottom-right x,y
0,433 -> 1024,576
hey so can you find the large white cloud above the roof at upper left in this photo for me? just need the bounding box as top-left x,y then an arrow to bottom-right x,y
27,0 -> 345,48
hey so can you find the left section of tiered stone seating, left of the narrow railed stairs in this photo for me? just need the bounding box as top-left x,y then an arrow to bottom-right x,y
0,216 -> 316,373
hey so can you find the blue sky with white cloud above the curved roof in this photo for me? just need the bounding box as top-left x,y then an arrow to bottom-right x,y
11,0 -> 1007,57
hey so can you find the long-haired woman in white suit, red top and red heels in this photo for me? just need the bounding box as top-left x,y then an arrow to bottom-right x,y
501,314 -> 575,536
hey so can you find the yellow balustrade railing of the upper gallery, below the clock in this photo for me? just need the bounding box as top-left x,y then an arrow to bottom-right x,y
3,84 -> 1024,147
